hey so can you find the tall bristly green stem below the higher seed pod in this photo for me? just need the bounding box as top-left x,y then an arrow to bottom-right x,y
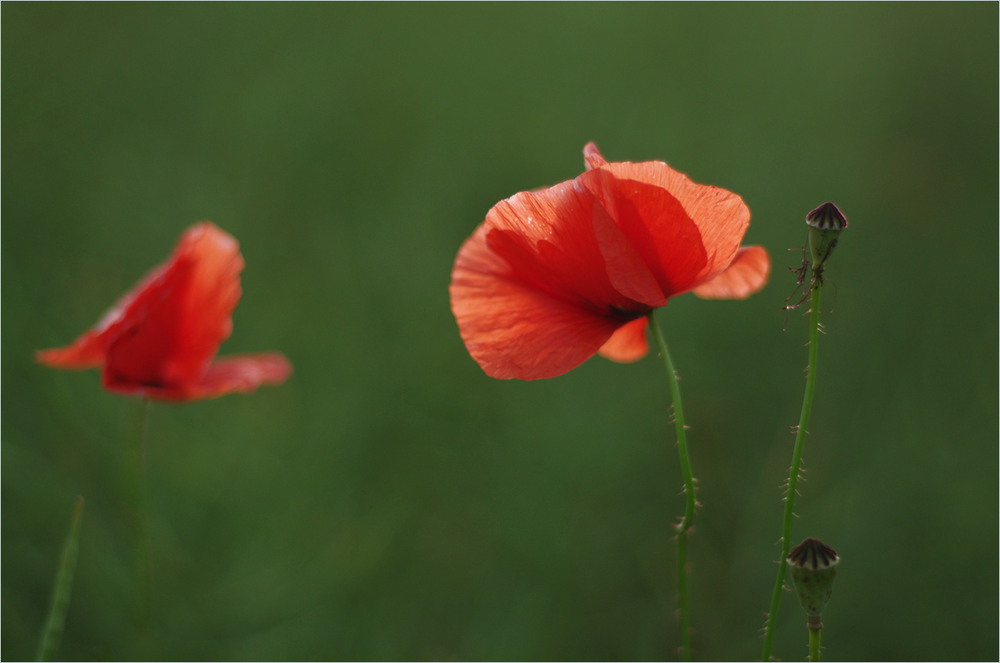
761,278 -> 823,661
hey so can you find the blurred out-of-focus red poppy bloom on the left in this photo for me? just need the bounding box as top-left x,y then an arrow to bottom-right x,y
37,221 -> 292,401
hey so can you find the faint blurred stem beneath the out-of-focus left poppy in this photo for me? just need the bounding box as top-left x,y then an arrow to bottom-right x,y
125,398 -> 153,642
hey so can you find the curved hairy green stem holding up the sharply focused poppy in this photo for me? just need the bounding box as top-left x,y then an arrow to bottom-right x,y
647,311 -> 695,661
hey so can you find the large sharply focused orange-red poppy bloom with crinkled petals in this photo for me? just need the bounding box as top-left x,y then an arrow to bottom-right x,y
450,143 -> 770,380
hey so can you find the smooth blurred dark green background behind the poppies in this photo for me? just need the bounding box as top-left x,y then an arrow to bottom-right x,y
2,3 -> 998,660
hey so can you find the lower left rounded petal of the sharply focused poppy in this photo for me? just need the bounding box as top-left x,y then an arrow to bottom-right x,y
450,224 -> 622,380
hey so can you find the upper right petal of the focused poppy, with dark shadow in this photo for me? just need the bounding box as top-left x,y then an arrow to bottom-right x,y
577,161 -> 750,297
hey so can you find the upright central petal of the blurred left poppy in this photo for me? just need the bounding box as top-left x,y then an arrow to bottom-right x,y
104,223 -> 243,390
